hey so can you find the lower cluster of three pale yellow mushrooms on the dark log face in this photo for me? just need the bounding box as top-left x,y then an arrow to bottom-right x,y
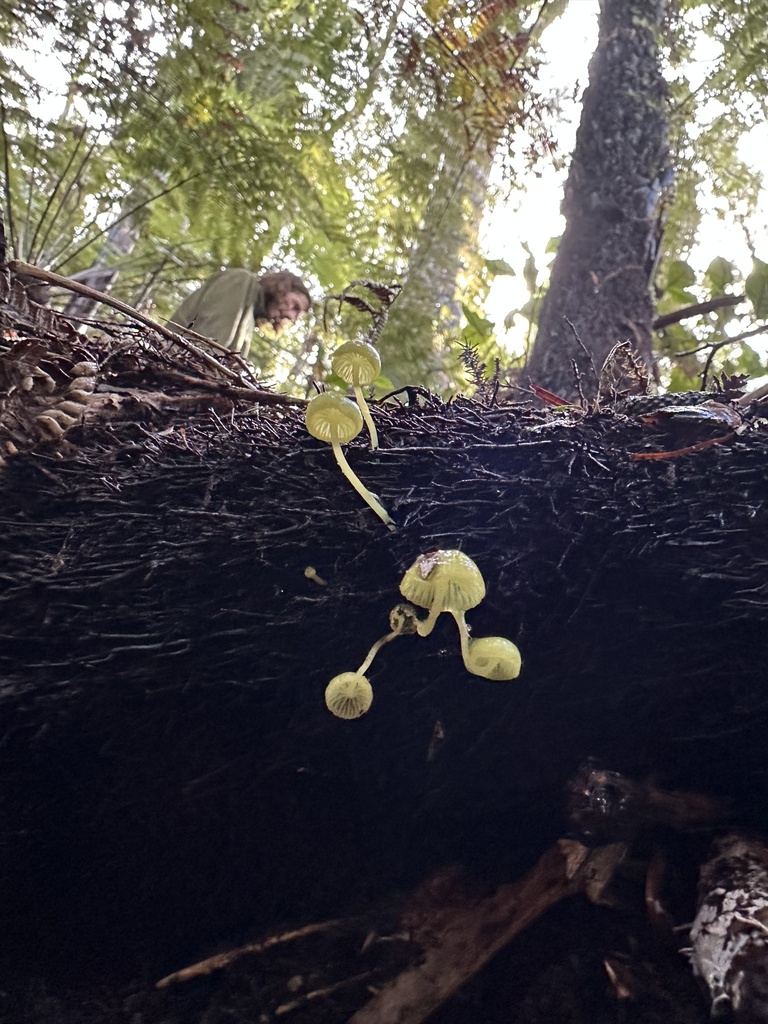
326,550 -> 521,719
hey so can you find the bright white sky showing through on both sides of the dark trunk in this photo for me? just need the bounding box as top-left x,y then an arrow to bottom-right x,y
481,0 -> 768,364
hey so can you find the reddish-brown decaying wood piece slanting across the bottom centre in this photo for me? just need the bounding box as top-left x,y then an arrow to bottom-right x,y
349,840 -> 627,1024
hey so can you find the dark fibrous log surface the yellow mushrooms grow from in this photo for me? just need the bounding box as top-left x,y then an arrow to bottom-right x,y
0,281 -> 768,1024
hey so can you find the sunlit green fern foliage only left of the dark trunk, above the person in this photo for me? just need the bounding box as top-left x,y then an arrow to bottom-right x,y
0,0 -> 564,387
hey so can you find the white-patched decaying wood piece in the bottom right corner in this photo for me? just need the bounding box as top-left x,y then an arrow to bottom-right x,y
690,835 -> 768,1024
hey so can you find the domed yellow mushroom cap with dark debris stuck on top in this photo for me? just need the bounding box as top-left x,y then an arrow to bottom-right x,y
400,550 -> 485,611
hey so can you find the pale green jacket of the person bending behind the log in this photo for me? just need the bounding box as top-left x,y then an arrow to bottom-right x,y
168,269 -> 263,356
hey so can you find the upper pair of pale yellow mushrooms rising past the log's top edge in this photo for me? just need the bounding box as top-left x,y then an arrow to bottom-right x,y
305,341 -> 395,529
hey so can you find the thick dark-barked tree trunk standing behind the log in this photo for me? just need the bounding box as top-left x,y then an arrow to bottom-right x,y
525,0 -> 669,397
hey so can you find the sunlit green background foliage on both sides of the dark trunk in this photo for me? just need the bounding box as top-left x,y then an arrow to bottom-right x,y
0,0 -> 768,391
